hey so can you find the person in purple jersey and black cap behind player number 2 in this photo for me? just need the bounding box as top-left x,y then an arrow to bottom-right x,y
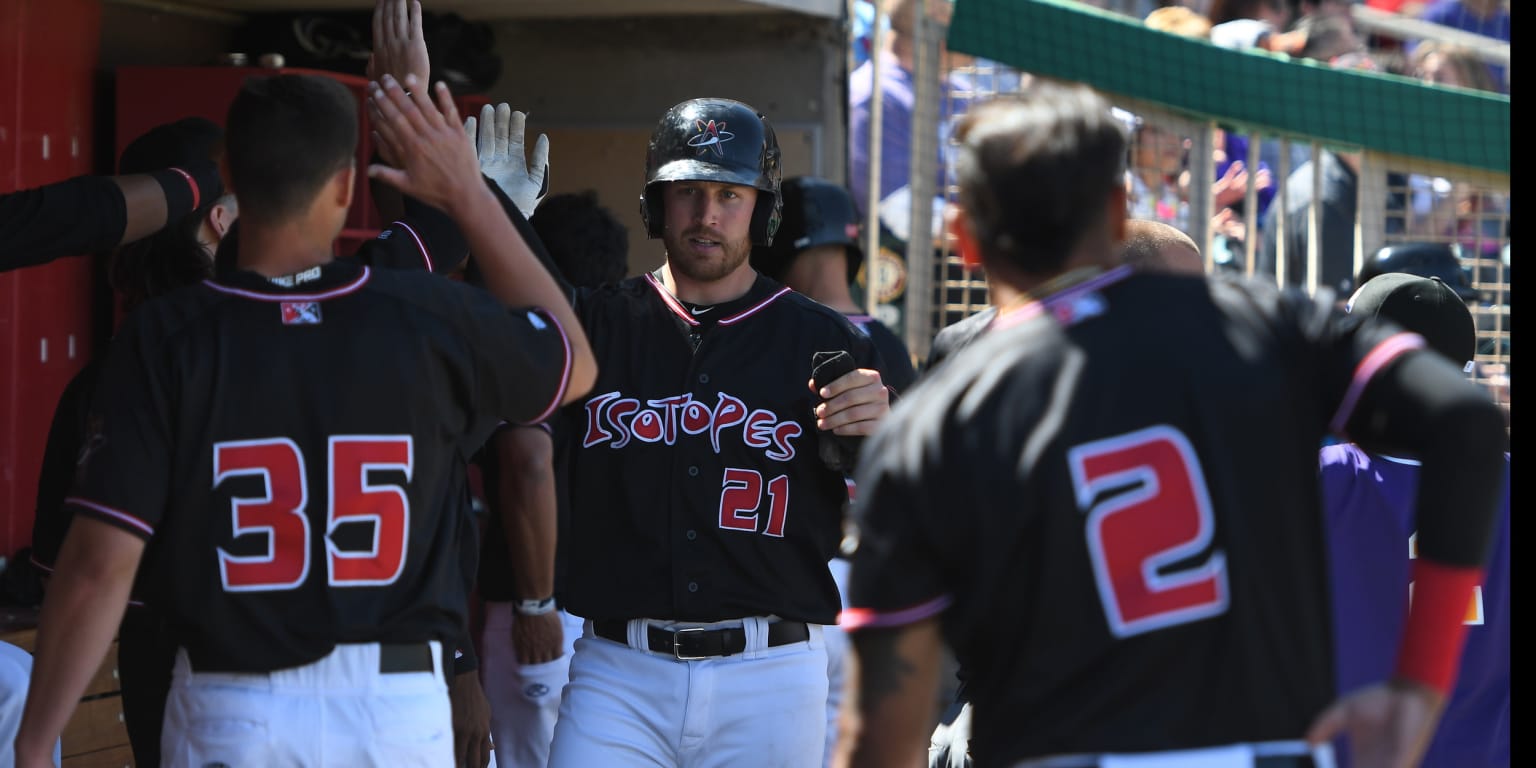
1321,272 -> 1513,768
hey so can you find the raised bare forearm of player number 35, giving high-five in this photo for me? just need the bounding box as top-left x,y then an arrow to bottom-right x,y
449,184 -> 598,404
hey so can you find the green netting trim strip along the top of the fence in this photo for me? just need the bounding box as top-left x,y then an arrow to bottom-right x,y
949,0 -> 1510,174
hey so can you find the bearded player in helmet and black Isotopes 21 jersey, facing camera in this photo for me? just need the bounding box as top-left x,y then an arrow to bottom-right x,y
550,98 -> 889,768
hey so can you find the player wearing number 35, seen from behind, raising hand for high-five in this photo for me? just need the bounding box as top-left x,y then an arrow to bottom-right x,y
15,75 -> 594,766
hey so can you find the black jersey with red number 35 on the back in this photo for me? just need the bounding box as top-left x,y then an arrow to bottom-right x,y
68,261 -> 571,671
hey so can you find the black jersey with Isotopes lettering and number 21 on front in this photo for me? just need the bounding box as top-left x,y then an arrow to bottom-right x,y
562,275 -> 880,624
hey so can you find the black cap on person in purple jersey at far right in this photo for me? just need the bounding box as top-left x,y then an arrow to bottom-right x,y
1346,272 -> 1478,366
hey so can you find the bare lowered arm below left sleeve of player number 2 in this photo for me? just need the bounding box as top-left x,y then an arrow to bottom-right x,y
842,619 -> 942,768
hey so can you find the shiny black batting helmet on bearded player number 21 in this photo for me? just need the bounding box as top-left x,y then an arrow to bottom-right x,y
641,98 -> 783,246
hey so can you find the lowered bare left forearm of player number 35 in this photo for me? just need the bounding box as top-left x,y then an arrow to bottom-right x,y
15,518 -> 144,765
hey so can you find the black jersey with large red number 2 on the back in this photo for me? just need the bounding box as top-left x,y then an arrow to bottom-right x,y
843,267 -> 1422,765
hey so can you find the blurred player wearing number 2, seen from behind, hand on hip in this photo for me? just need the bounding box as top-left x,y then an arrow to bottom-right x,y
842,80 -> 1504,768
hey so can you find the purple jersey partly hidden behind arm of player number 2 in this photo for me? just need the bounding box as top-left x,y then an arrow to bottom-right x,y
1321,444 -> 1510,768
